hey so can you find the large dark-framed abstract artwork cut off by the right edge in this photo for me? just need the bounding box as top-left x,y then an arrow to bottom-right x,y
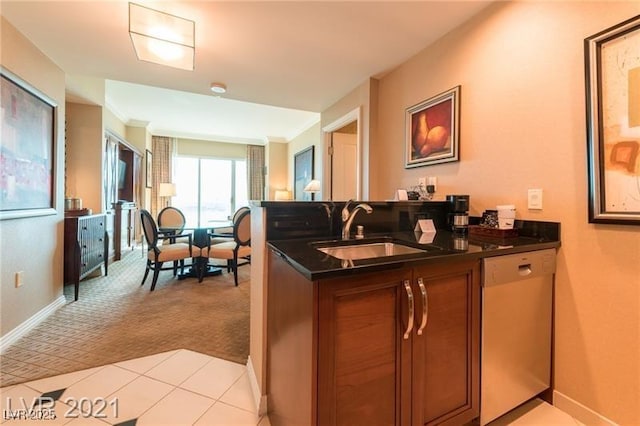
584,15 -> 640,225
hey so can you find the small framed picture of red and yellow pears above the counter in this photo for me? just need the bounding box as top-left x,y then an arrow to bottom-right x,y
405,86 -> 460,168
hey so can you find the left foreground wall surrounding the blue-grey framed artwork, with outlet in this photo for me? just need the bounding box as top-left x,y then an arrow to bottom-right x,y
0,17 -> 65,336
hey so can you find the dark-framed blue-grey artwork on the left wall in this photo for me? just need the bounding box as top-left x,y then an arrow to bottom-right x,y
0,67 -> 57,219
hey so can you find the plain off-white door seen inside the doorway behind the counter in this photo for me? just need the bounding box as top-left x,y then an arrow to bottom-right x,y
331,132 -> 358,201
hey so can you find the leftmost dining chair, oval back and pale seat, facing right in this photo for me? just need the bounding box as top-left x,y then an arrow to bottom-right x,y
140,209 -> 200,291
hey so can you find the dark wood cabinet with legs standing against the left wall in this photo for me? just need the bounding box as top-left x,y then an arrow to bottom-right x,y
64,214 -> 109,300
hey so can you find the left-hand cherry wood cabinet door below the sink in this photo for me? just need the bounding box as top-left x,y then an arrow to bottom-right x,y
317,270 -> 411,426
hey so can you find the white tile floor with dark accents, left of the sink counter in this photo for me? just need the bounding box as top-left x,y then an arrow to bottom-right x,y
0,349 -> 269,426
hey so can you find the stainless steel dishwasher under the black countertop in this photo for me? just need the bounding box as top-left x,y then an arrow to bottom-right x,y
480,249 -> 556,425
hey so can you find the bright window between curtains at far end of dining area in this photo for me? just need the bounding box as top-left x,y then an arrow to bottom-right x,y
173,157 -> 248,226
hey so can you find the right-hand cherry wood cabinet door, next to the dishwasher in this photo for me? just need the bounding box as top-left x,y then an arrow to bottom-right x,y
413,261 -> 480,425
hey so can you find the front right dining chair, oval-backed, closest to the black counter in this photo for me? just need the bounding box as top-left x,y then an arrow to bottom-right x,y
202,207 -> 251,286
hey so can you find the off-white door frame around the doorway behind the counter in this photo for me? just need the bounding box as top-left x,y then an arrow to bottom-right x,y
322,106 -> 362,200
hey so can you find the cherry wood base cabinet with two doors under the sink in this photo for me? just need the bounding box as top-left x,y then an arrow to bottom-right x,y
267,252 -> 480,426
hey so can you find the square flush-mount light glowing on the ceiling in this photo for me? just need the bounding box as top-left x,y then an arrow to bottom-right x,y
129,3 -> 195,71
